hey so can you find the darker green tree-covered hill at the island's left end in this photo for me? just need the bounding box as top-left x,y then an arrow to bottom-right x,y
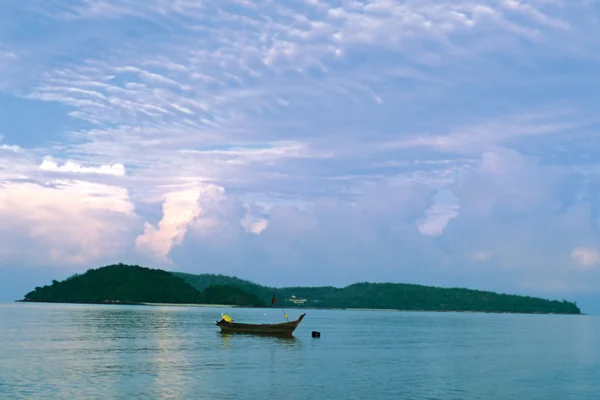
23,264 -> 264,306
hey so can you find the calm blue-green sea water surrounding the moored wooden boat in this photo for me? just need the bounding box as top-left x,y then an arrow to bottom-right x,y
0,304 -> 600,400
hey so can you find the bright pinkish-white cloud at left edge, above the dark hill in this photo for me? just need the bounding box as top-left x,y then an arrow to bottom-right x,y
0,180 -> 137,268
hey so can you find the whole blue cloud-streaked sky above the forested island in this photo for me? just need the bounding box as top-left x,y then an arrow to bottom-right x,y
0,0 -> 600,311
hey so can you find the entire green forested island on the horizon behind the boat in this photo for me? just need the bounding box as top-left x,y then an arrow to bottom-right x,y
19,264 -> 581,314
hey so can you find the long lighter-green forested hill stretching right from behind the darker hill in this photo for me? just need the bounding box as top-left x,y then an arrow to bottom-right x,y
175,273 -> 581,314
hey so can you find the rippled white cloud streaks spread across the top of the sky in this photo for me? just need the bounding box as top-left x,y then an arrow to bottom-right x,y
22,0 -> 592,134
